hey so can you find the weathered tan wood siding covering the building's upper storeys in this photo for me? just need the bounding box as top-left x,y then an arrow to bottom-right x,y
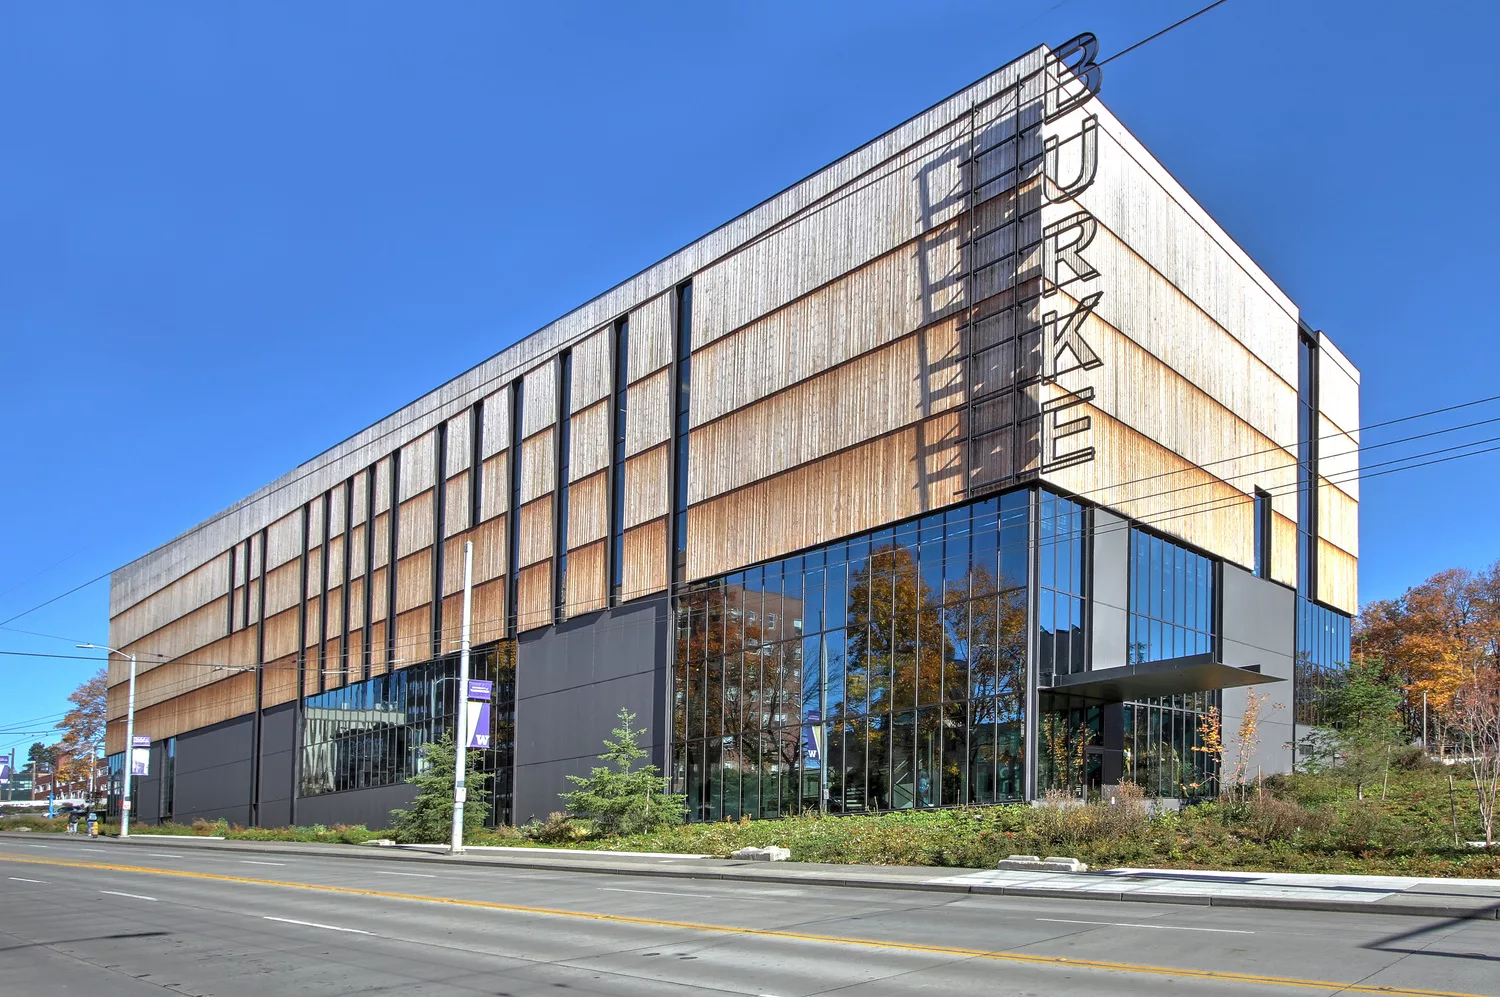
108,40 -> 1359,753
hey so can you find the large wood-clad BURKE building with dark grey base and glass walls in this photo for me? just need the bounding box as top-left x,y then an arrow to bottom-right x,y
99,36 -> 1359,825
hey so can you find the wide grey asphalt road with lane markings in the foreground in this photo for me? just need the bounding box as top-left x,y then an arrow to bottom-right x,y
0,838 -> 1500,997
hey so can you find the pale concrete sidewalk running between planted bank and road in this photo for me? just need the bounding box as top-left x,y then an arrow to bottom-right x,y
0,832 -> 1500,921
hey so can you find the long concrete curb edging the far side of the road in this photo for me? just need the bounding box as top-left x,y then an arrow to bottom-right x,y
0,831 -> 1500,921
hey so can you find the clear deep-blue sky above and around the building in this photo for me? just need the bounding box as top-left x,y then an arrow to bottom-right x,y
0,0 -> 1500,750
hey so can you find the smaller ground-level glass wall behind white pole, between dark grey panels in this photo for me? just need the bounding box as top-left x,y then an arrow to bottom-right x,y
300,640 -> 516,823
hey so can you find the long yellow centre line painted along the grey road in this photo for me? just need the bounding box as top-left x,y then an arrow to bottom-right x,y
0,853 -> 1493,997
